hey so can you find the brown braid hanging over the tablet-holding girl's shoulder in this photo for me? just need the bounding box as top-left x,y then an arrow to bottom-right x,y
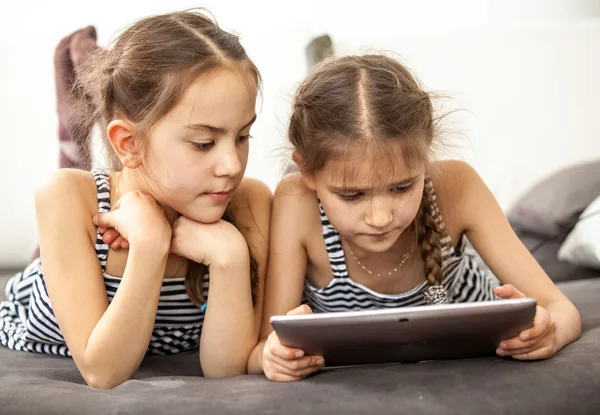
417,177 -> 446,286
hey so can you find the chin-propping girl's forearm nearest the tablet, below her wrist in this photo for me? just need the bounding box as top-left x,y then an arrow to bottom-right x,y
200,256 -> 254,377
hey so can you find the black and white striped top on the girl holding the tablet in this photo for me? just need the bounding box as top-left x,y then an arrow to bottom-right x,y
302,202 -> 500,313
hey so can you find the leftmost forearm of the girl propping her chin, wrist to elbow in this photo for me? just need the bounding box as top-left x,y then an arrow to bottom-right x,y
82,247 -> 168,387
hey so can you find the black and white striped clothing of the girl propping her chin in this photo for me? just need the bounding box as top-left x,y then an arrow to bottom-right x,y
0,170 -> 209,356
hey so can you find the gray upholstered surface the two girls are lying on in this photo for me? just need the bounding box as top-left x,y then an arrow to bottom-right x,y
0,279 -> 600,414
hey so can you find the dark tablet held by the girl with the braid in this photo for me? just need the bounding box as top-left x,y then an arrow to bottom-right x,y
271,298 -> 537,366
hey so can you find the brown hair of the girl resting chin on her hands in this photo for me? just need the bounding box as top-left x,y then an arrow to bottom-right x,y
75,11 -> 261,304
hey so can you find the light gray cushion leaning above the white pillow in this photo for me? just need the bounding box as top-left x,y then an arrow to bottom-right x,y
507,161 -> 600,237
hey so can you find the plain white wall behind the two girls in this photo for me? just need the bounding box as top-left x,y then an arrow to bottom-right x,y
0,0 -> 600,267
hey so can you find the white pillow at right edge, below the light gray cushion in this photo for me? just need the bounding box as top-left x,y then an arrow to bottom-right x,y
558,196 -> 600,269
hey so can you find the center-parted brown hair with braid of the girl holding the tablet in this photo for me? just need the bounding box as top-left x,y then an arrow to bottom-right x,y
288,55 -> 445,285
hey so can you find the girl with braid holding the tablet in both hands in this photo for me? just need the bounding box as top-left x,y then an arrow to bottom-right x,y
249,55 -> 581,381
